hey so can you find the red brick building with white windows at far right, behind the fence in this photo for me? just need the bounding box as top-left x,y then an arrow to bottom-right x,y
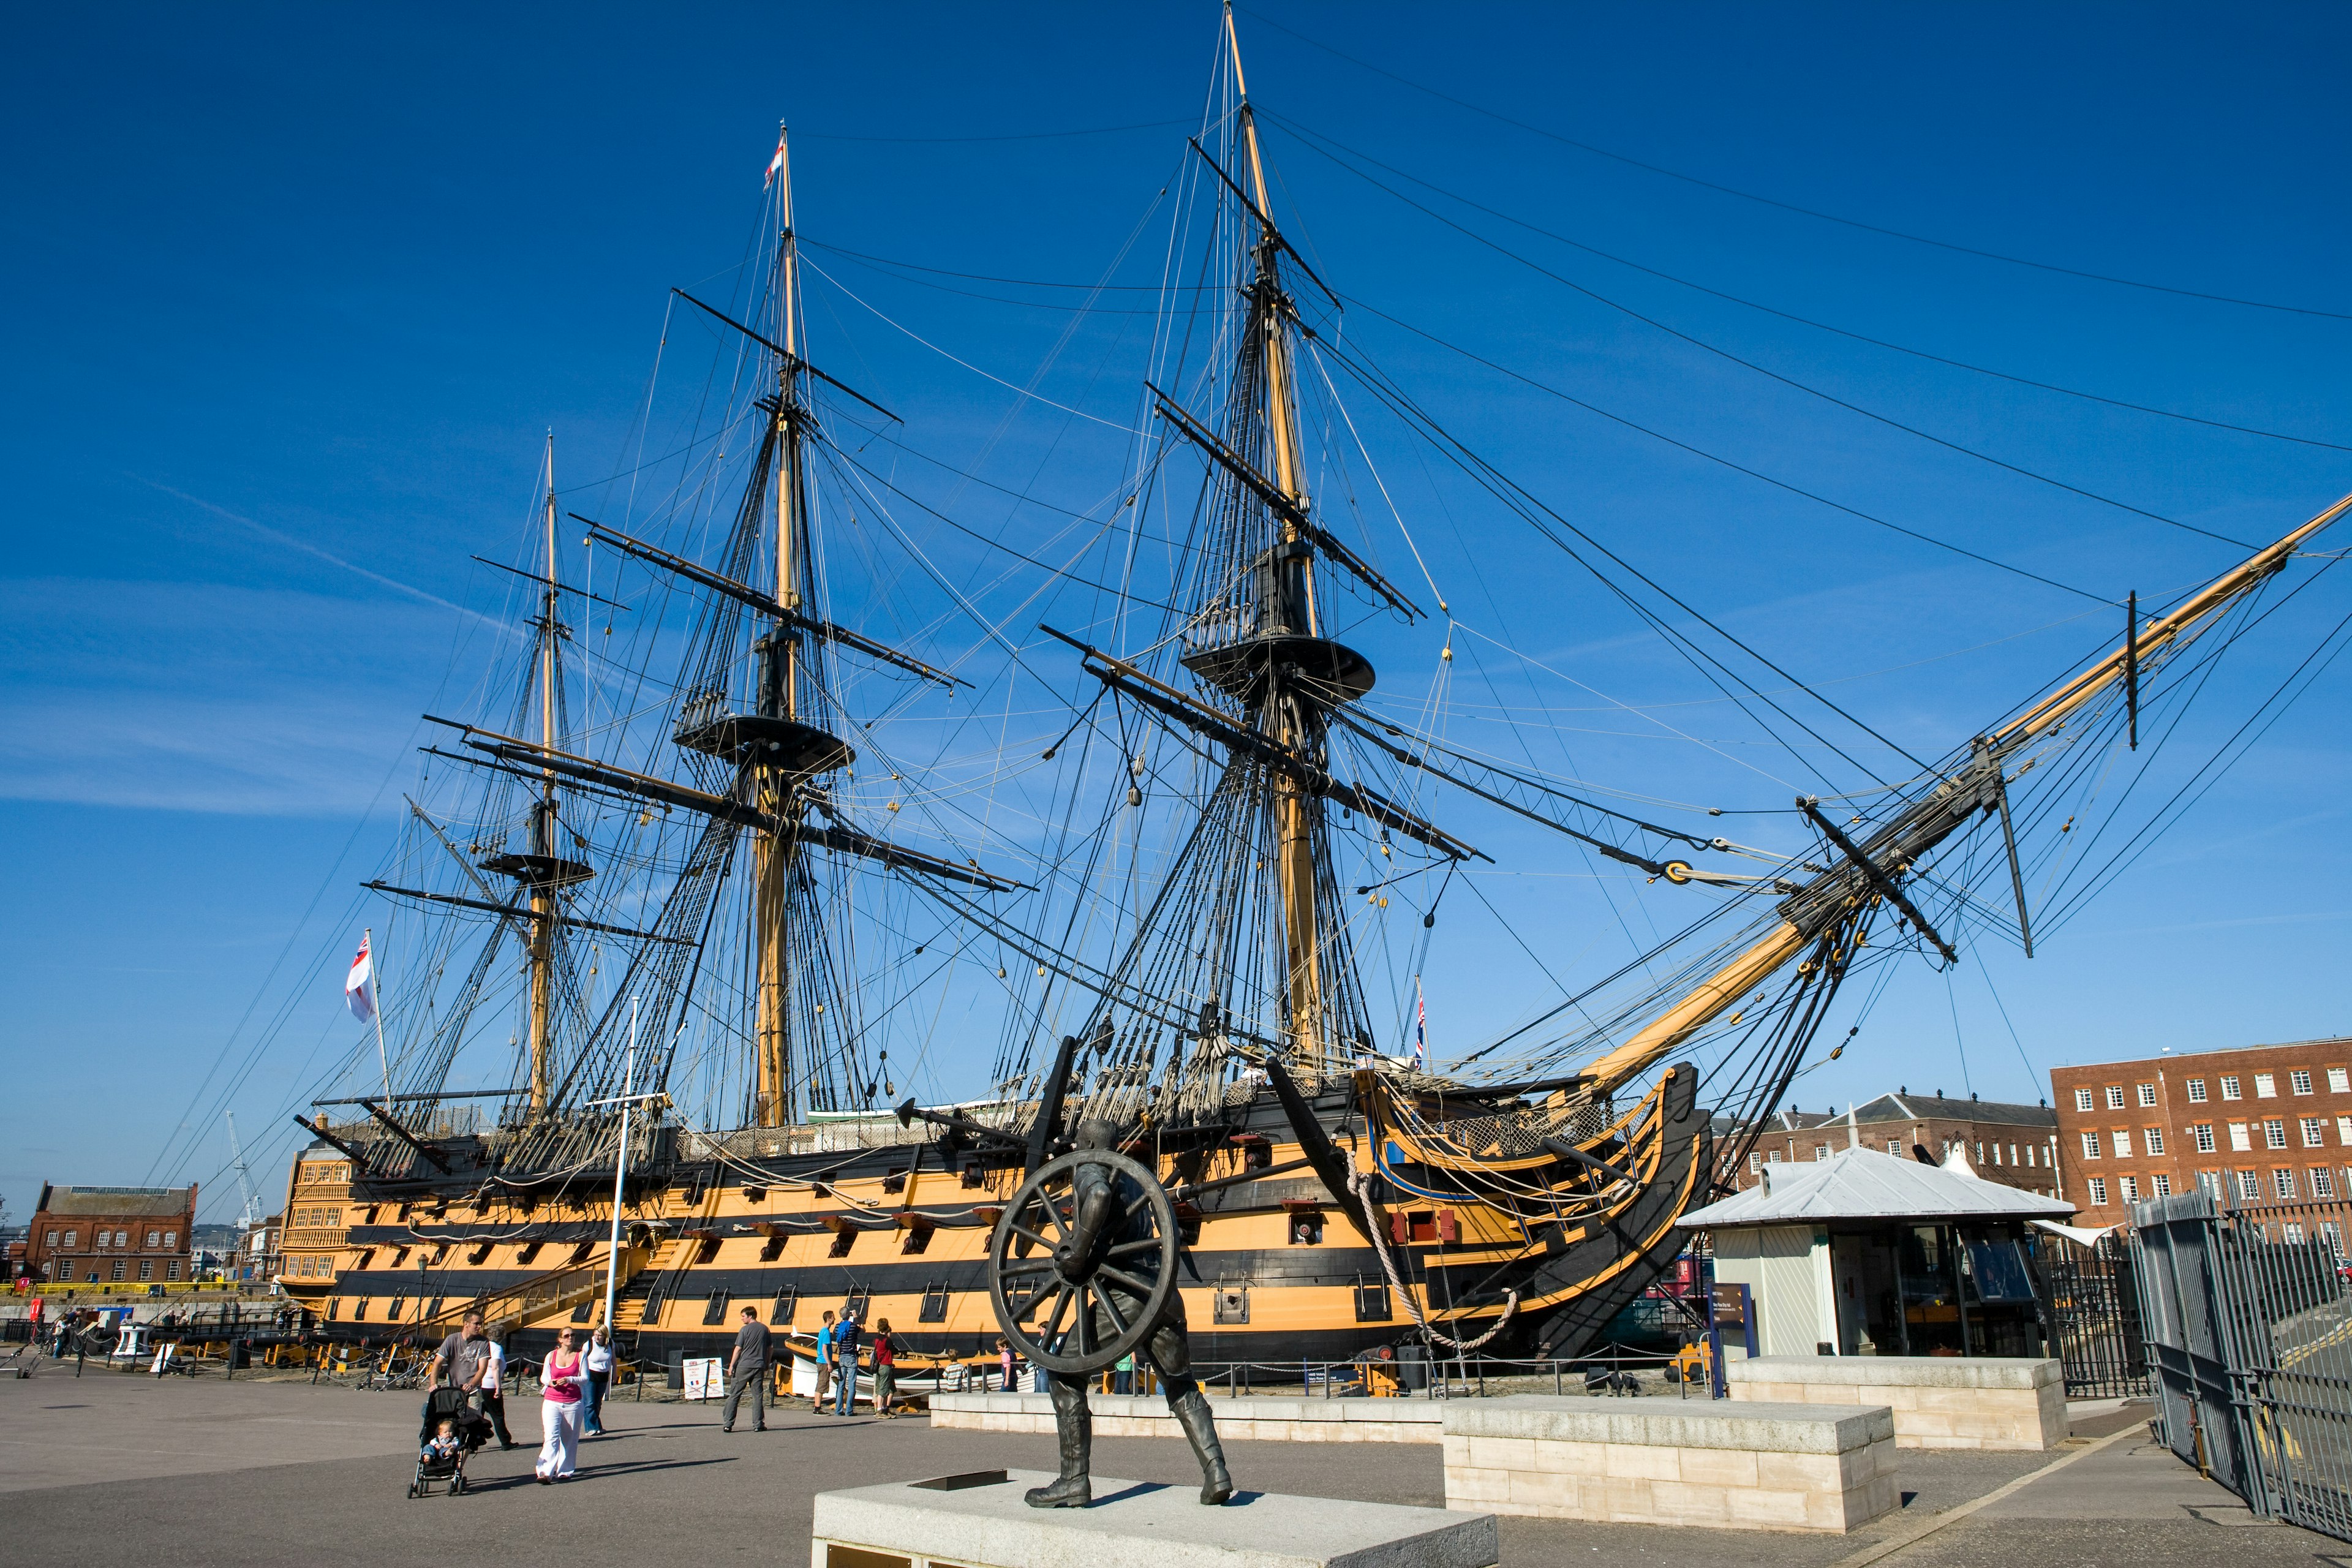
2051,1039 -> 2352,1225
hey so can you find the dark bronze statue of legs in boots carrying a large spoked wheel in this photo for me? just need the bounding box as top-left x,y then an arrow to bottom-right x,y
988,1121 -> 1232,1509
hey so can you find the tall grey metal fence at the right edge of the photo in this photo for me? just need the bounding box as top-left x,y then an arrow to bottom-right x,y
2133,1183 -> 2352,1540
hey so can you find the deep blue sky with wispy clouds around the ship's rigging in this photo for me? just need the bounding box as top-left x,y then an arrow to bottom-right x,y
0,5 -> 2352,1218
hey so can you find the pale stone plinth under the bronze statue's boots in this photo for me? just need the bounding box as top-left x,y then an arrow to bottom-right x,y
809,1469 -> 1501,1568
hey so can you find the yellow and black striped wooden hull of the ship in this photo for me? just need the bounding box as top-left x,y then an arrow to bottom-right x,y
285,1067 -> 1710,1378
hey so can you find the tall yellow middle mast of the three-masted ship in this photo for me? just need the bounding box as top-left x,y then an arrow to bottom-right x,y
753,124 -> 809,1126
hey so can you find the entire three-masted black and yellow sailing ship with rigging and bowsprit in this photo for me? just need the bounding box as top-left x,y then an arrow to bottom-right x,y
282,14 -> 2347,1368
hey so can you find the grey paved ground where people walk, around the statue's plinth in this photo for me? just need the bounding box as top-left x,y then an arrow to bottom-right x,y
0,1363 -> 2352,1568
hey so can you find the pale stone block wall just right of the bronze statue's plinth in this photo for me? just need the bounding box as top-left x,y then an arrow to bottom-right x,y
1444,1394 -> 1898,1535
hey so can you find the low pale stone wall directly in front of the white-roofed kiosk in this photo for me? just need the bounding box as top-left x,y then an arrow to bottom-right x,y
1724,1357 -> 2067,1453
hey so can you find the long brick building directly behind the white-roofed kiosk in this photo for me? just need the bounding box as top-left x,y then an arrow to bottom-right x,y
1714,1088 -> 2070,1197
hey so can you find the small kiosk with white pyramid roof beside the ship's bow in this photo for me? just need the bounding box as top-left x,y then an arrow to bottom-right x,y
1682,1147 -> 2075,1357
